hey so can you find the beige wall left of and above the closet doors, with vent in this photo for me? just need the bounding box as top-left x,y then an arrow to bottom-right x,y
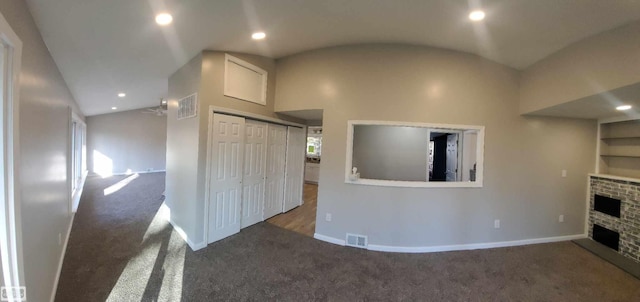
166,51 -> 277,245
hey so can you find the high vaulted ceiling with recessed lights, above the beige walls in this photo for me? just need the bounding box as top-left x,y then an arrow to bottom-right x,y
27,0 -> 640,116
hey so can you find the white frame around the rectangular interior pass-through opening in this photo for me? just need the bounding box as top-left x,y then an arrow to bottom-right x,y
344,120 -> 484,188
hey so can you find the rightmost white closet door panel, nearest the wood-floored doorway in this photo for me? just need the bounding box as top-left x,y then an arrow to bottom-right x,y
282,126 -> 306,212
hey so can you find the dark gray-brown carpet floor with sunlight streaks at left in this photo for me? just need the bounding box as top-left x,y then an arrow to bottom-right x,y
56,173 -> 640,301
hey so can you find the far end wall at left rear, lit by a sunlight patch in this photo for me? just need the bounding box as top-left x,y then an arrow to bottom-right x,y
86,109 -> 167,174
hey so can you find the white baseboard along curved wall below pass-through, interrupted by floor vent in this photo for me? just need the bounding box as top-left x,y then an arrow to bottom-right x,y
313,233 -> 587,253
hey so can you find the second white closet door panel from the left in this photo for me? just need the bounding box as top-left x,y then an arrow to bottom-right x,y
241,120 -> 267,228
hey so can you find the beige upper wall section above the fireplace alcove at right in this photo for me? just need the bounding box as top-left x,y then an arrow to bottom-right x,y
519,21 -> 640,114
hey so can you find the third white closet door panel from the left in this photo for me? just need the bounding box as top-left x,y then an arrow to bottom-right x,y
263,124 -> 287,220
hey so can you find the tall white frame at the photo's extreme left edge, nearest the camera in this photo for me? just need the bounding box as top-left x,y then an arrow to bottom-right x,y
0,8 -> 24,301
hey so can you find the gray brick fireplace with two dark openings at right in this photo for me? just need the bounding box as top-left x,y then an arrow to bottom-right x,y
589,174 -> 640,263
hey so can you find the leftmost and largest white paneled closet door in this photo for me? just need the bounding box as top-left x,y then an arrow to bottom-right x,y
207,114 -> 245,243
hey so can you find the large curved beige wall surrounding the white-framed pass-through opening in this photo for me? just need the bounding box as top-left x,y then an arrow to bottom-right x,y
275,45 -> 596,247
